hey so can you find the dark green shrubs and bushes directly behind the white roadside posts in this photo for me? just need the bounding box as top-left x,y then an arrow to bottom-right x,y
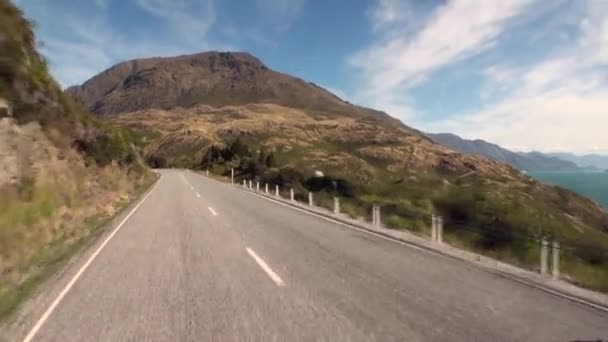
199,138 -> 608,291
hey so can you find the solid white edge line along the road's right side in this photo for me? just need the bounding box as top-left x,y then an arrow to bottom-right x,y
245,191 -> 608,312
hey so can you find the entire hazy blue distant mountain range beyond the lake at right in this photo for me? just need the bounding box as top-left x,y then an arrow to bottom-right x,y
427,133 -> 608,171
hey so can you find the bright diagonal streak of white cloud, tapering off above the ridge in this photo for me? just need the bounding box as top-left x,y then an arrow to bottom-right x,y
349,0 -> 530,100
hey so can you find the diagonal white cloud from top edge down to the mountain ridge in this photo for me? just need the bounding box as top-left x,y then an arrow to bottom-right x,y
348,0 -> 531,120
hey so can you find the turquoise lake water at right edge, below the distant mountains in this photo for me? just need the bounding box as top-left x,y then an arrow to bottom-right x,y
528,171 -> 608,209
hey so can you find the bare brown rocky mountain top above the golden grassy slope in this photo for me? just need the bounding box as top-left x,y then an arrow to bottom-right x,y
67,52 -> 395,122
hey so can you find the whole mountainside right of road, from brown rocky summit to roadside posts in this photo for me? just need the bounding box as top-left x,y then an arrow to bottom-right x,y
69,52 -> 608,289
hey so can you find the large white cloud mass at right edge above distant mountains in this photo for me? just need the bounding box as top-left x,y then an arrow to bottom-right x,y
425,3 -> 608,153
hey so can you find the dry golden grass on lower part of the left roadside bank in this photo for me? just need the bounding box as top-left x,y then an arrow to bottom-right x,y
0,120 -> 151,316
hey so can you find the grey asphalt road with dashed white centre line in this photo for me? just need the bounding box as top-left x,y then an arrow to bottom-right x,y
23,170 -> 608,342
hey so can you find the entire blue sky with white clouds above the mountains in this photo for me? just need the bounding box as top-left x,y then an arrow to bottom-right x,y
16,0 -> 608,154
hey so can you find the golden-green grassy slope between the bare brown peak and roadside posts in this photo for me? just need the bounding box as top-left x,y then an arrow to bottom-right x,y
113,105 -> 608,291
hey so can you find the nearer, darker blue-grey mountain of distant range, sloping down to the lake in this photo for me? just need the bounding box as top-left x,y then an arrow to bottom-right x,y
427,133 -> 579,171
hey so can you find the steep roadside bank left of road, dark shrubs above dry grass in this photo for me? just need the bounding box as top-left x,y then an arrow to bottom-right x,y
0,0 -> 153,320
